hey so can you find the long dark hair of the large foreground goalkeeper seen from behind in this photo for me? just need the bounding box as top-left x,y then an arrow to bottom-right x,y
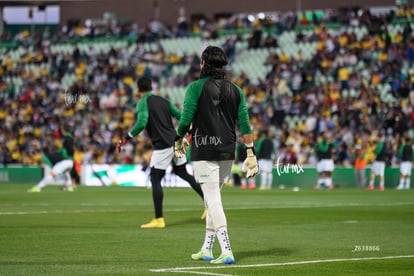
200,46 -> 228,78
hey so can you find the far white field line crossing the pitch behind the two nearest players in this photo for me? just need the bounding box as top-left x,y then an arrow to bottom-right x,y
0,202 -> 414,216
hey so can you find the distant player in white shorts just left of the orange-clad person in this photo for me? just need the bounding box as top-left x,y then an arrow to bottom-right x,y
315,132 -> 335,190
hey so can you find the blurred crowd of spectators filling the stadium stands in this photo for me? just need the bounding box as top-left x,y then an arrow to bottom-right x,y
0,4 -> 414,172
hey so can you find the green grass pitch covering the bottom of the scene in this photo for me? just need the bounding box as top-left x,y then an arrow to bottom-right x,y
0,184 -> 414,276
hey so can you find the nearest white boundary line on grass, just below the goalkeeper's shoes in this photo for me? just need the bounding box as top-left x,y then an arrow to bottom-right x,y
149,255 -> 414,276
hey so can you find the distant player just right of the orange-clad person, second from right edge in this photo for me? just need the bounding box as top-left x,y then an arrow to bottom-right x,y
367,134 -> 386,191
